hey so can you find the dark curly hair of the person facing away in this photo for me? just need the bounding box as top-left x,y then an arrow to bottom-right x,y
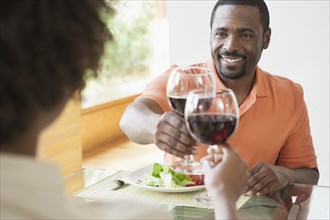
0,0 -> 113,144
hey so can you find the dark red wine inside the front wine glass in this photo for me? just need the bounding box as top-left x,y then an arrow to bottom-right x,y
188,114 -> 237,145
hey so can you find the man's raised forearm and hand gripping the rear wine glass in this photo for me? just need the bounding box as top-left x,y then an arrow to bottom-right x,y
120,98 -> 197,158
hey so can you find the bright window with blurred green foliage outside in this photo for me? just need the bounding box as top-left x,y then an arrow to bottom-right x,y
82,0 -> 169,108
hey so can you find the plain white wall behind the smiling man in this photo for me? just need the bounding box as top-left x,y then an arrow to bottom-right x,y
168,1 -> 330,186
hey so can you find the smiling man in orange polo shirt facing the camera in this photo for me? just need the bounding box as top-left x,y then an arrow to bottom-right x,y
120,0 -> 319,194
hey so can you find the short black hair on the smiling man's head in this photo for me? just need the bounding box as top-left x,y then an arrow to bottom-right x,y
210,0 -> 269,33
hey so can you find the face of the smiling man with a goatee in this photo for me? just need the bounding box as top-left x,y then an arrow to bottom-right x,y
210,5 -> 270,79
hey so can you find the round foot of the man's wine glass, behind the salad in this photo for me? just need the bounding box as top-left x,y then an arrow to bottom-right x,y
171,160 -> 202,174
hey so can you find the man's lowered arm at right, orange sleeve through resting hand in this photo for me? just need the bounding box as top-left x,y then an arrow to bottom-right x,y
247,85 -> 319,194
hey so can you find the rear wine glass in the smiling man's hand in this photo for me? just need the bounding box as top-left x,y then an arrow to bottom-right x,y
166,66 -> 215,174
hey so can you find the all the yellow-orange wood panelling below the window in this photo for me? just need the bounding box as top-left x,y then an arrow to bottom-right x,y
37,91 -> 138,175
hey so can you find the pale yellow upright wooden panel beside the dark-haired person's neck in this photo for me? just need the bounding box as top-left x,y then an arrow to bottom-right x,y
37,99 -> 82,176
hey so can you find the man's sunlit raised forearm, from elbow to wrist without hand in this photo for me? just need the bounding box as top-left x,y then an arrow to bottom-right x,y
119,99 -> 163,144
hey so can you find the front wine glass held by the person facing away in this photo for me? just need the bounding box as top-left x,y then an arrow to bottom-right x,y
185,88 -> 239,204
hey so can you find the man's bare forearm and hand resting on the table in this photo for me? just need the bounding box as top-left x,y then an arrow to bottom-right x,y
247,163 -> 319,195
